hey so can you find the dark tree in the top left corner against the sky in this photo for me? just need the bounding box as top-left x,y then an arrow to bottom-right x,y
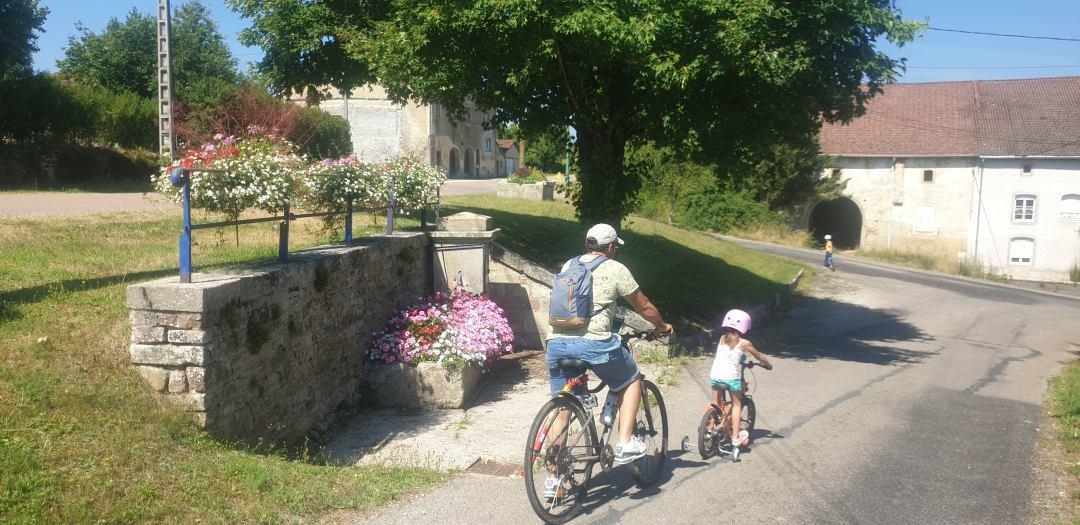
0,0 -> 49,79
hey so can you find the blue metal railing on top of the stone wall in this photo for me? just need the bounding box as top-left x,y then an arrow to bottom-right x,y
168,167 -> 440,283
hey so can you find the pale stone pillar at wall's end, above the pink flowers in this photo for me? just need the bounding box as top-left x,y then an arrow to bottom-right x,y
429,212 -> 500,294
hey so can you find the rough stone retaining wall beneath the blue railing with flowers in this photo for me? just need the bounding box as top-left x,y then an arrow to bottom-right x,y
127,233 -> 431,443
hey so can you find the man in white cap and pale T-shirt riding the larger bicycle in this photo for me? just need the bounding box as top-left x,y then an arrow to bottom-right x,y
546,224 -> 672,465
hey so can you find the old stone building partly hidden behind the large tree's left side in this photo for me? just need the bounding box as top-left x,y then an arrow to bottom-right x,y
302,84 -> 507,178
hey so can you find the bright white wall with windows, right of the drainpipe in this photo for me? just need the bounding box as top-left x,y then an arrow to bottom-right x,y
971,159 -> 1080,281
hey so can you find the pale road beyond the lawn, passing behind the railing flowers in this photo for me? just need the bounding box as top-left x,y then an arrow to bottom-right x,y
0,179 -> 498,218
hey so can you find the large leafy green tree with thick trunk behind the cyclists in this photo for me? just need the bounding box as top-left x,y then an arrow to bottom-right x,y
230,0 -> 919,224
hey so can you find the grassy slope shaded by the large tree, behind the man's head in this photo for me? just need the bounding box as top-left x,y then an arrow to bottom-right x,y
443,196 -> 799,326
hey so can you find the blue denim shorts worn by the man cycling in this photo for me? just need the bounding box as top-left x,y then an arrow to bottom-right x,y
546,335 -> 640,394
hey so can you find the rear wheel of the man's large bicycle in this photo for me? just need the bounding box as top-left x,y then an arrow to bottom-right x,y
525,396 -> 596,524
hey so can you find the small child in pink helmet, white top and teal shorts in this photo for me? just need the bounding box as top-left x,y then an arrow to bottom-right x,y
704,310 -> 772,458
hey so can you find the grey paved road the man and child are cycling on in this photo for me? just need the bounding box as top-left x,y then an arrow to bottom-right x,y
358,239 -> 1080,524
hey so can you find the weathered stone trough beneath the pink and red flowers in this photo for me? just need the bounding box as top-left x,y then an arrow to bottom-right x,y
366,362 -> 484,408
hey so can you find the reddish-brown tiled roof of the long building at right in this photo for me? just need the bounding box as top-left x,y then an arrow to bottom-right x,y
821,77 -> 1080,157
